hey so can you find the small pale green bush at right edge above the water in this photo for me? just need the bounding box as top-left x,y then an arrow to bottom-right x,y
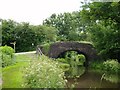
103,59 -> 120,72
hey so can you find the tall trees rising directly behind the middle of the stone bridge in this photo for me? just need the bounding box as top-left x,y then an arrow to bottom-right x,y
43,11 -> 87,41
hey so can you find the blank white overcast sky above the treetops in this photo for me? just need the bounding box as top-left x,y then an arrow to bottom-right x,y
0,0 -> 84,25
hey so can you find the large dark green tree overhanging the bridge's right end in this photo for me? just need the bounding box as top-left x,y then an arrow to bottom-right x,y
81,2 -> 120,61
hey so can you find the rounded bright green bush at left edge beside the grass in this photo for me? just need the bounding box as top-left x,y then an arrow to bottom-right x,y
0,46 -> 15,67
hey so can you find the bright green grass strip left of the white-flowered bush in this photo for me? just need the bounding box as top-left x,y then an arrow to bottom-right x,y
2,54 -> 36,88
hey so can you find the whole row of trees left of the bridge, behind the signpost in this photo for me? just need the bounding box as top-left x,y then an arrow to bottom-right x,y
2,20 -> 57,52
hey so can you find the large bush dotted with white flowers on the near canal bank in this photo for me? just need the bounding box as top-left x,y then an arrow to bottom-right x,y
24,56 -> 66,88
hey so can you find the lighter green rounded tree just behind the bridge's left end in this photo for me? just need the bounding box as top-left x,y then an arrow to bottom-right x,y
34,25 -> 57,43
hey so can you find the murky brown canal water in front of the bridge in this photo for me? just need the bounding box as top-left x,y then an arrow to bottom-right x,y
66,68 -> 120,90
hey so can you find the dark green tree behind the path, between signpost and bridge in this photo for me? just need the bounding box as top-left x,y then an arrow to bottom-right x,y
15,22 -> 36,52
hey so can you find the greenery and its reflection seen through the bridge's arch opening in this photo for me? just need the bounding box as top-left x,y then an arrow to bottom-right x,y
58,50 -> 86,77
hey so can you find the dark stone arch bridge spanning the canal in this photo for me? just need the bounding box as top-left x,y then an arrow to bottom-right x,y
36,42 -> 97,66
